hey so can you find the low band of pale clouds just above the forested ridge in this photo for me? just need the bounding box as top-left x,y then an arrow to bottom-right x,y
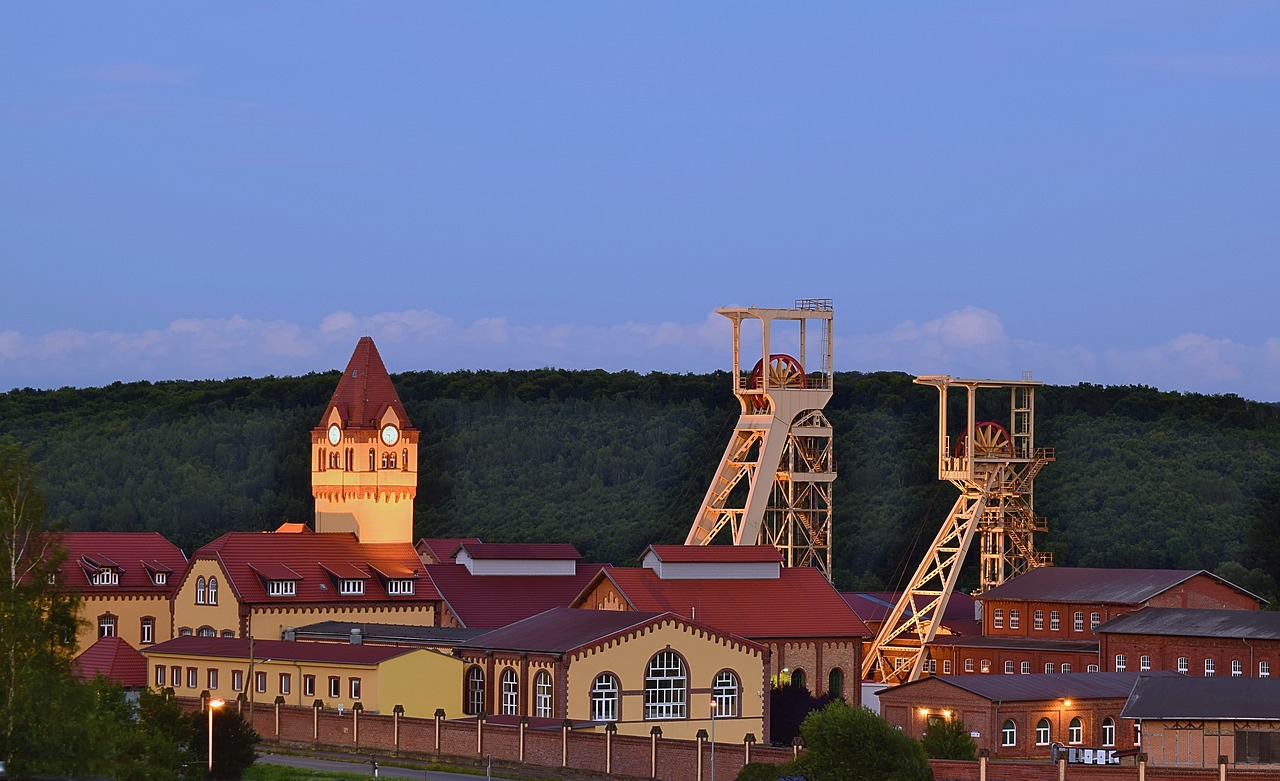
0,306 -> 1280,401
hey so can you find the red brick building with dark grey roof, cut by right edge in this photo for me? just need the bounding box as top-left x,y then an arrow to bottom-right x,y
1097,607 -> 1280,676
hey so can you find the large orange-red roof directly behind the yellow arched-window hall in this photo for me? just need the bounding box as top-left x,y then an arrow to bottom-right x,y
573,567 -> 872,640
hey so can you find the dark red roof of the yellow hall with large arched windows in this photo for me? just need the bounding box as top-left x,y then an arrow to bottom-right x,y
457,607 -> 763,654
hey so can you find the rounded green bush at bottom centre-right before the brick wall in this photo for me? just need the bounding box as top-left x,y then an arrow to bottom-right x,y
797,700 -> 933,781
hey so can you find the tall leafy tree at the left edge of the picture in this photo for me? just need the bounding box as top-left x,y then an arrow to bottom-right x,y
0,438 -> 79,775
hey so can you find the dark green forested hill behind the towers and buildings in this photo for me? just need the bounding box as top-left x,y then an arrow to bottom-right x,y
0,369 -> 1280,602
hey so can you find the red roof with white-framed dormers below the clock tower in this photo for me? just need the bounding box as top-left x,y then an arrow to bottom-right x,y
192,531 -> 439,604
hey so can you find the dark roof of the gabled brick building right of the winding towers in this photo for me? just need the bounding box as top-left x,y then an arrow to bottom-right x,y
982,567 -> 1261,604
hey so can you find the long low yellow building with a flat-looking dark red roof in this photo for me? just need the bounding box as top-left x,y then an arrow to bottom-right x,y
143,636 -> 462,718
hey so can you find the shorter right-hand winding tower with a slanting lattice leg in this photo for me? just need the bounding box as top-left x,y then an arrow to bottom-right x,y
863,375 -> 1053,684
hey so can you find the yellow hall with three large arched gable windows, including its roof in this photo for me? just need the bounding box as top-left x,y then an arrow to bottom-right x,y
454,608 -> 769,743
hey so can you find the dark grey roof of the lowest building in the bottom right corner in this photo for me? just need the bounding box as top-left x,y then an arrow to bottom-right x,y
1120,677 -> 1280,721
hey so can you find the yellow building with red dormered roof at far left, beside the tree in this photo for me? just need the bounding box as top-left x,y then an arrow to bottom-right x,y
54,531 -> 187,652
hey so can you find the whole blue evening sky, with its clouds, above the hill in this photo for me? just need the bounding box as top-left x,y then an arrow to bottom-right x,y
0,0 -> 1280,401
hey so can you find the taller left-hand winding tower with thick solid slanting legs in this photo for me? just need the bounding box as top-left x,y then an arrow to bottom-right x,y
685,298 -> 836,580
